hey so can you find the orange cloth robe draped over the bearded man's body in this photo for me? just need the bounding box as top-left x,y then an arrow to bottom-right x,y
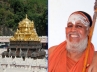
48,41 -> 94,72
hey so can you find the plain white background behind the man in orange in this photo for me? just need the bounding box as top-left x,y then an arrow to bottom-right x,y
48,0 -> 97,50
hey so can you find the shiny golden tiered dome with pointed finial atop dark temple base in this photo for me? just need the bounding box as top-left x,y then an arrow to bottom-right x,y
10,15 -> 40,41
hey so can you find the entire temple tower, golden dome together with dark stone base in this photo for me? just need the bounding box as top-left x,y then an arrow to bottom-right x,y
2,15 -> 46,58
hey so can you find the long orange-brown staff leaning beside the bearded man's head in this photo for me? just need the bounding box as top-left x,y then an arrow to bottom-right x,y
82,0 -> 97,72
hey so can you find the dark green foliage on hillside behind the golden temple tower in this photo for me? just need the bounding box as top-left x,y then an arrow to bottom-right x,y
0,0 -> 48,36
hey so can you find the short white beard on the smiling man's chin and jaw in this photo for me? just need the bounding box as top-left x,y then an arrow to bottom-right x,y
66,37 -> 88,52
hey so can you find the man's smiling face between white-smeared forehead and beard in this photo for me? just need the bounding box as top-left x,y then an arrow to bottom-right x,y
66,20 -> 88,43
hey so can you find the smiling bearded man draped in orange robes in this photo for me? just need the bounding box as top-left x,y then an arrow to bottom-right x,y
48,11 -> 97,72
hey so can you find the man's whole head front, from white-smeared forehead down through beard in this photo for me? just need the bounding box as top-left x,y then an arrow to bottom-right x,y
66,13 -> 90,52
